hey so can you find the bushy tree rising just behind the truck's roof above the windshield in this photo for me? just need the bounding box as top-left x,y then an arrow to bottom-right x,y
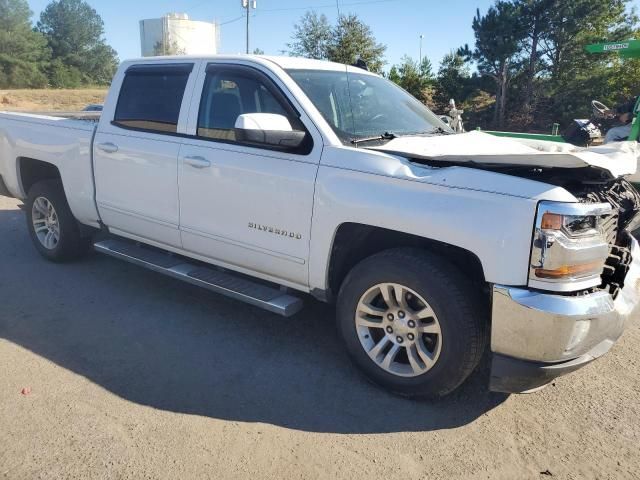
327,14 -> 387,73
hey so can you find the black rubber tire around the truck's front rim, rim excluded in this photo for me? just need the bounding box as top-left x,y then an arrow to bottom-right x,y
337,248 -> 488,398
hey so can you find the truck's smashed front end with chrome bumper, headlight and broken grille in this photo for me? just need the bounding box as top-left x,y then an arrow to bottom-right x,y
491,174 -> 640,393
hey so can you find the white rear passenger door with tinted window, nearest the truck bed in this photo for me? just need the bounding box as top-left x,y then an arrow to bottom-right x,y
94,62 -> 195,247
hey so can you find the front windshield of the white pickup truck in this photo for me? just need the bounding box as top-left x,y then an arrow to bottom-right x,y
287,69 -> 451,145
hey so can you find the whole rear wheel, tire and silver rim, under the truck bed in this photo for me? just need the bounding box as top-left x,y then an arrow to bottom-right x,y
25,180 -> 90,262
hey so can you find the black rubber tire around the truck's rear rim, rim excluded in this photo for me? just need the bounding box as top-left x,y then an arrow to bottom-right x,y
25,180 -> 90,262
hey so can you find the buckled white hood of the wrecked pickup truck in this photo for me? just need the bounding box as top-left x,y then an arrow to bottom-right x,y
370,131 -> 640,178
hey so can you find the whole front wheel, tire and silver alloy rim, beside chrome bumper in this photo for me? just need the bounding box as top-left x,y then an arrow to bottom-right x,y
337,249 -> 487,397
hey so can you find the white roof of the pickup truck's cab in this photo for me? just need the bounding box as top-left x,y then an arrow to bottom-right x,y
123,54 -> 374,75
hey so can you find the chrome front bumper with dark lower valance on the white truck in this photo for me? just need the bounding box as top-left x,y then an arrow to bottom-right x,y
490,233 -> 640,393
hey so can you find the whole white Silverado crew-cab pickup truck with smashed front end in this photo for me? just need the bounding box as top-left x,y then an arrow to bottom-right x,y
0,56 -> 640,397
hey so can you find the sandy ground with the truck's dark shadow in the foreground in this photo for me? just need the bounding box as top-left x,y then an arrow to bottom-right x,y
0,193 -> 640,480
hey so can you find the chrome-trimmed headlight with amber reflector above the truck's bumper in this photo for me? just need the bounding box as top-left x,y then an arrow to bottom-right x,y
529,202 -> 616,291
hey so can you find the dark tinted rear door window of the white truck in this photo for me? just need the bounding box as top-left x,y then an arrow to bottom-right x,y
113,63 -> 193,133
